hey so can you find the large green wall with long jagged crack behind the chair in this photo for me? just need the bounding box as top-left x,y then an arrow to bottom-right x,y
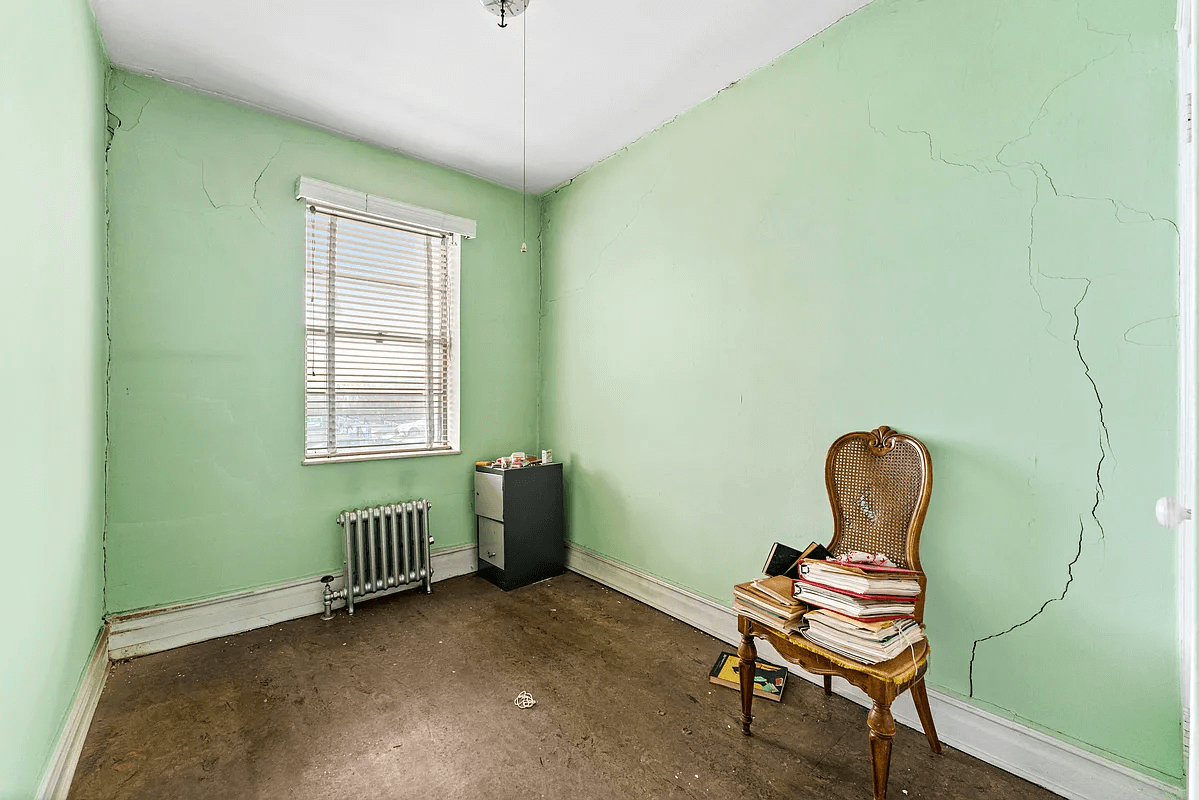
540,0 -> 1182,783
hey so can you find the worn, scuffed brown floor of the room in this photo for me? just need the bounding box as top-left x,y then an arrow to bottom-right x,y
71,575 -> 1056,800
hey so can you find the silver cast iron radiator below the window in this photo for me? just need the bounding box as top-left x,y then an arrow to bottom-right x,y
321,500 -> 433,619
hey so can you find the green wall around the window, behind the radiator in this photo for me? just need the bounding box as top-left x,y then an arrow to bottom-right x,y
107,71 -> 541,612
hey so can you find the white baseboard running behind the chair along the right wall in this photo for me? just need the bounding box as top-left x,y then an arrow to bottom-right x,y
566,543 -> 1185,800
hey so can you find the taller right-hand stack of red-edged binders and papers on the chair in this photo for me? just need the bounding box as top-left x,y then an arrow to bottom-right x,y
793,559 -> 924,664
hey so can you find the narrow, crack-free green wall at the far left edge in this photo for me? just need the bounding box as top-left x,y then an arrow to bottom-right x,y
0,0 -> 107,798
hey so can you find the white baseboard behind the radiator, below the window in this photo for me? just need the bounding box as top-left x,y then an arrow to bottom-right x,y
108,545 -> 477,660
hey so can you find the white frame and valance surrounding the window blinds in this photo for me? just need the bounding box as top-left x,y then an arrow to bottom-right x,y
296,178 -> 476,465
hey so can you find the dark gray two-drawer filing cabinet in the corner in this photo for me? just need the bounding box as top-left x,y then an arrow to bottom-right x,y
475,464 -> 566,591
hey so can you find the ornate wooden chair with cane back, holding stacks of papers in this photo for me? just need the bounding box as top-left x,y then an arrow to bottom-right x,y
737,426 -> 941,800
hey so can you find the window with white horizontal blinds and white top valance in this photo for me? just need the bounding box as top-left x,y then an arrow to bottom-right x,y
299,179 -> 474,464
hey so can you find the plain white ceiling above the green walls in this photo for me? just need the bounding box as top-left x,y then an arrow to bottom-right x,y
92,0 -> 869,193
